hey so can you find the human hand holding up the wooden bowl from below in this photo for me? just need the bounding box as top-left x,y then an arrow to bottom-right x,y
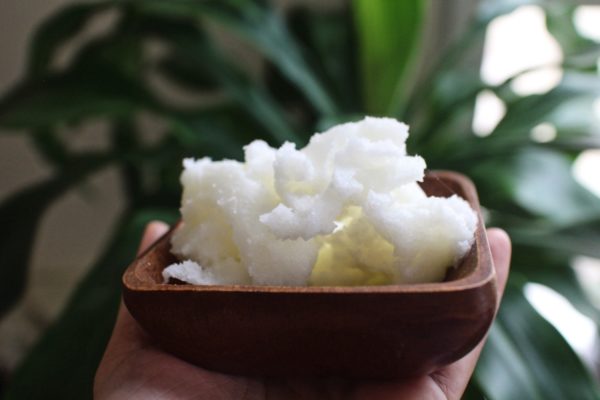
94,222 -> 511,400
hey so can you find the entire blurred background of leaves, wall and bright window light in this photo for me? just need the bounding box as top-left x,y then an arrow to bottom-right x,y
0,0 -> 600,399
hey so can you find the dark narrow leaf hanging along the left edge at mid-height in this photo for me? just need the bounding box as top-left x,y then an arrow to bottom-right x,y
0,155 -> 108,317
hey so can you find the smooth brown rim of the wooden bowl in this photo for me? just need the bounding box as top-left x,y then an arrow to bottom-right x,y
122,171 -> 496,294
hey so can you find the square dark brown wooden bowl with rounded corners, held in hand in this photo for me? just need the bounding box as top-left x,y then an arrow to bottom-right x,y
123,172 -> 497,379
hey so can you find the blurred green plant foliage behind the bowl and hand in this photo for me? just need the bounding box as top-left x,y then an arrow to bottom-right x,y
0,0 -> 600,399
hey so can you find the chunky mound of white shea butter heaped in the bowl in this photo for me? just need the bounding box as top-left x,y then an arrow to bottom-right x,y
163,117 -> 477,286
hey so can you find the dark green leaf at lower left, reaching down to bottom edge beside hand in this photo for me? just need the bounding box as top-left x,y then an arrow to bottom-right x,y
5,210 -> 177,400
